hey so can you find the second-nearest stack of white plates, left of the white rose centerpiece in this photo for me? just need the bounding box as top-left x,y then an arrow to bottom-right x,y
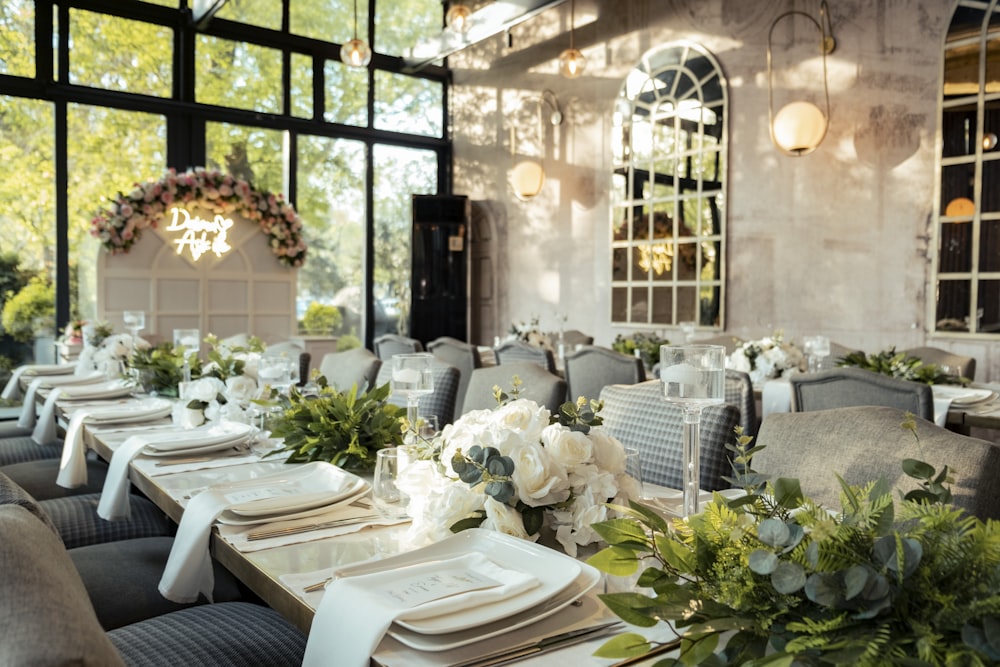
213,461 -> 370,526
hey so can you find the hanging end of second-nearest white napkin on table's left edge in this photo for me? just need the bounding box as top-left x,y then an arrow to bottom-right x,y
159,489 -> 230,603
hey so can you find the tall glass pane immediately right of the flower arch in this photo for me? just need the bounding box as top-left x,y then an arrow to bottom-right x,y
296,136 -> 366,336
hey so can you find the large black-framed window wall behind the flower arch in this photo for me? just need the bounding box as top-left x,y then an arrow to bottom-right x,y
0,0 -> 451,354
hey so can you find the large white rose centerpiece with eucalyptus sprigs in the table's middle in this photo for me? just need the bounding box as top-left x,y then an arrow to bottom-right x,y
398,381 -> 640,556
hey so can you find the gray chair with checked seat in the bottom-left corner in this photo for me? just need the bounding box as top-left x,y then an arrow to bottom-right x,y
0,505 -> 306,667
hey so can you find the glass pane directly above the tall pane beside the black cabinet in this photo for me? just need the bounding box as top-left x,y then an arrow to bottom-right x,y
375,71 -> 444,137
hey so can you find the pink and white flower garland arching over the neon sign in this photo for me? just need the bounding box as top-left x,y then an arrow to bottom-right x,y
90,167 -> 306,268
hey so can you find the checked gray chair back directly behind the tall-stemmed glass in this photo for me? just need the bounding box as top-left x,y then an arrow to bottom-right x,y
601,380 -> 740,491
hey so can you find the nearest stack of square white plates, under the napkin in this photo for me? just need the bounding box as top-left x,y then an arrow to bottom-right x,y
333,529 -> 601,651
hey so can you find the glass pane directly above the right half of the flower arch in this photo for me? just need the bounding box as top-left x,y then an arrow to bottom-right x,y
205,123 -> 284,193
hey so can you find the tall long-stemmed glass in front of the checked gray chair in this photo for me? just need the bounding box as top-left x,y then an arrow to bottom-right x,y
660,345 -> 726,517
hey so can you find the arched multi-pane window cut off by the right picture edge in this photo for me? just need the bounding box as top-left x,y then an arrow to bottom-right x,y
931,0 -> 1000,336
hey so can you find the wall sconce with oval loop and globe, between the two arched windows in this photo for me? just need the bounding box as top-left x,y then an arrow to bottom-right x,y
767,0 -> 836,157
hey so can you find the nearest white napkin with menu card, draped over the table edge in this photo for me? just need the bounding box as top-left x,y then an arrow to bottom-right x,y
302,552 -> 538,667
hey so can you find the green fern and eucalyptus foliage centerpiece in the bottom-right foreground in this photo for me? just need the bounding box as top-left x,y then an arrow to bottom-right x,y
590,420 -> 1000,667
